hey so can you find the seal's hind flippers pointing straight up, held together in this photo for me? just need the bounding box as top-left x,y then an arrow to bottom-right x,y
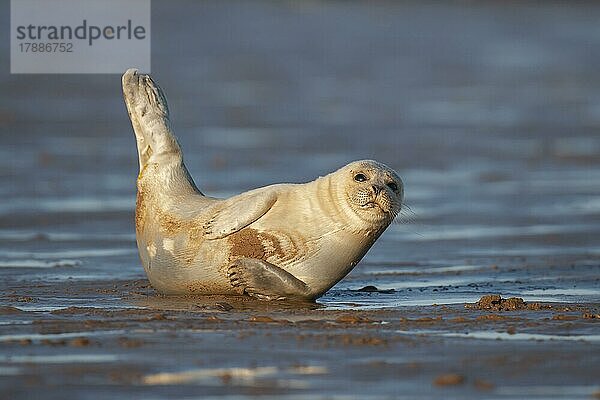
121,68 -> 181,171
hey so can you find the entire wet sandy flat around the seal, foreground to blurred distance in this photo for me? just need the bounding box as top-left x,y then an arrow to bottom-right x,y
0,1 -> 600,399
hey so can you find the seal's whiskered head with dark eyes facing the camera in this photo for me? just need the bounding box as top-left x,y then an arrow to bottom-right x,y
332,160 -> 404,227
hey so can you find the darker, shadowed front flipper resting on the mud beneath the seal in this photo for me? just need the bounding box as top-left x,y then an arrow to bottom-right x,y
227,258 -> 311,300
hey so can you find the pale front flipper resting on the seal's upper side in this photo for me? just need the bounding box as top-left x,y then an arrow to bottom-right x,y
203,190 -> 277,239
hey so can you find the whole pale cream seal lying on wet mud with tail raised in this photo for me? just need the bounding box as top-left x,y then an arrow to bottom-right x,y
122,69 -> 404,300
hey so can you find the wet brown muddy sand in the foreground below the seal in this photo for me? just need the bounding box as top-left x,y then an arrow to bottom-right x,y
0,280 -> 600,399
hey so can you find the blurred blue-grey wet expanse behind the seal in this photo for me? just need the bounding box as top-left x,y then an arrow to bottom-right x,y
0,0 -> 600,306
